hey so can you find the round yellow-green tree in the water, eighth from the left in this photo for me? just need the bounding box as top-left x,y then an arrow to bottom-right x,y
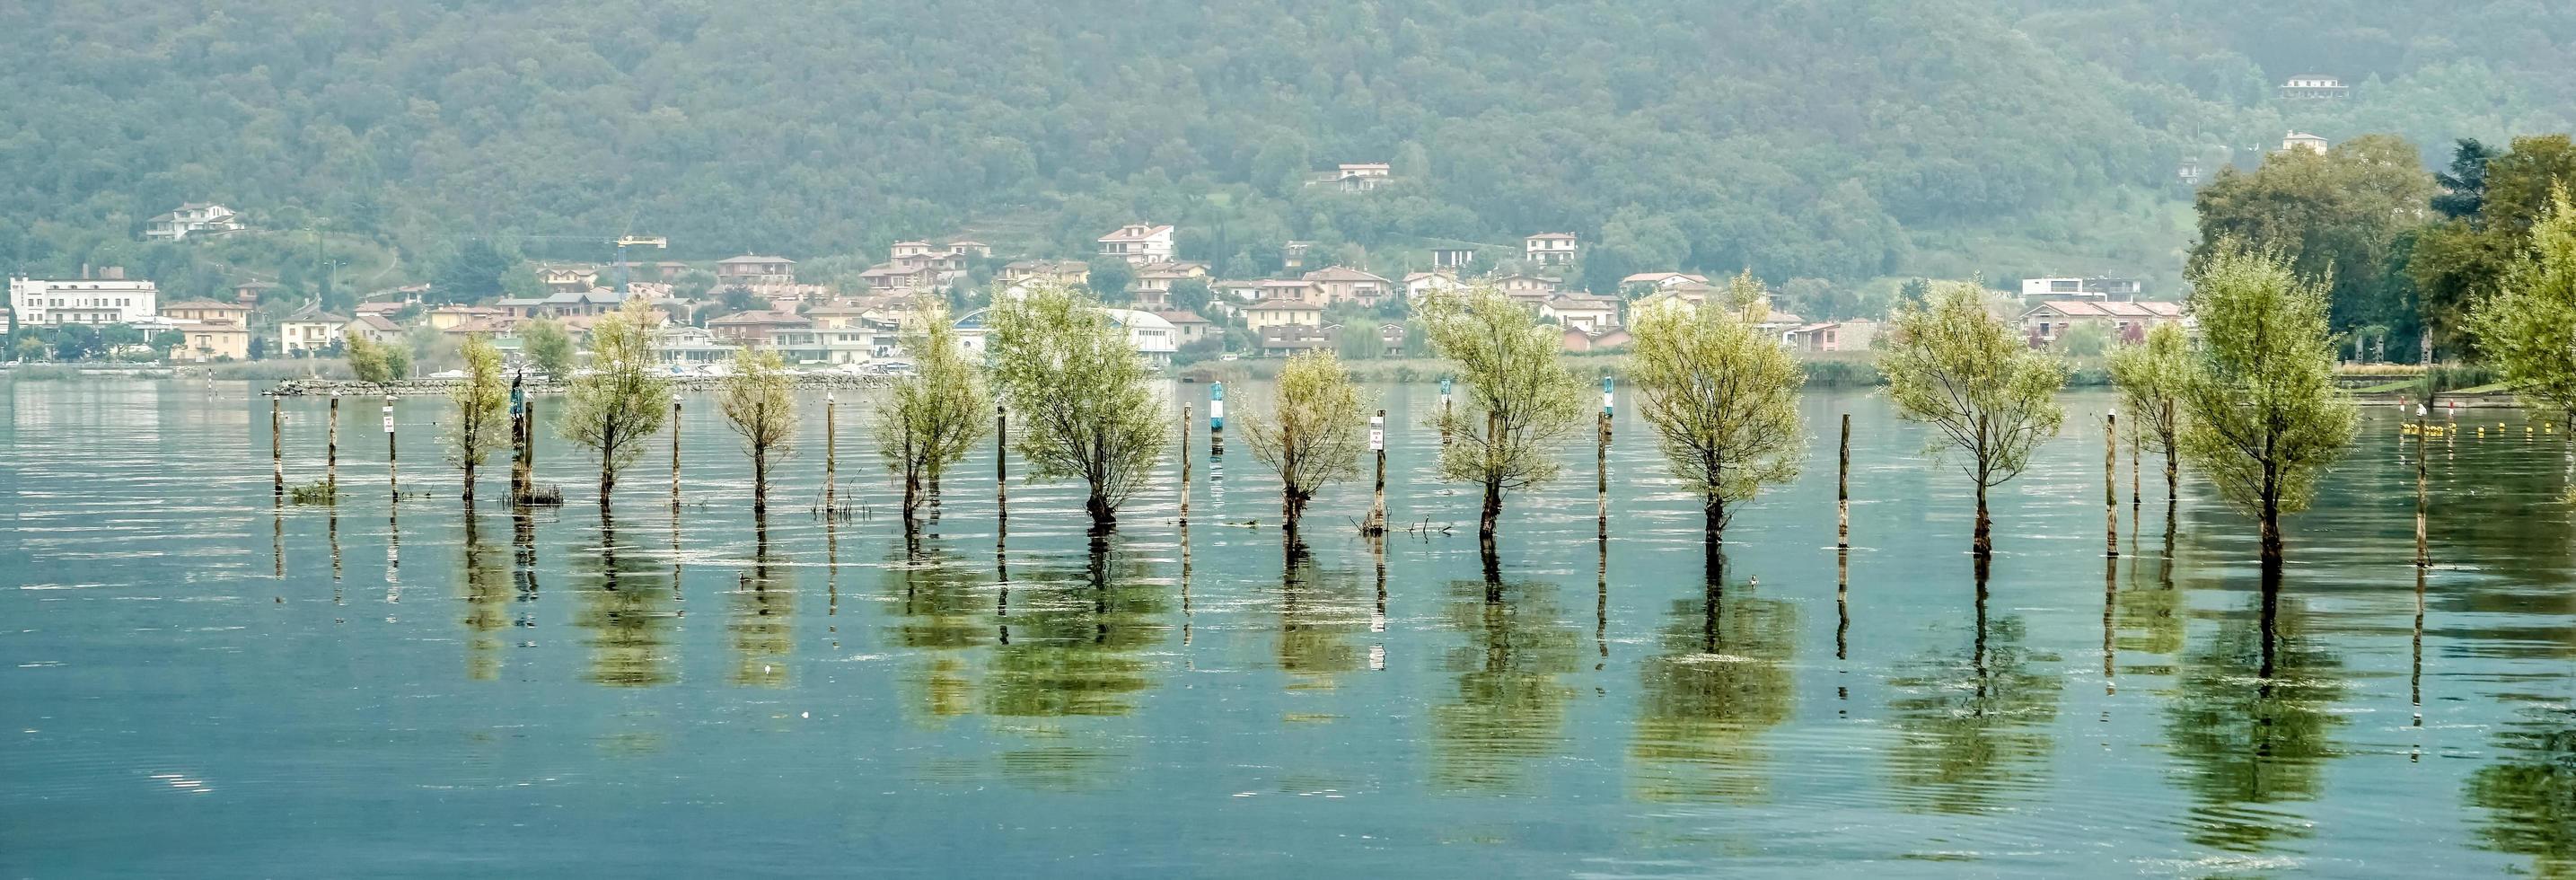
1628,273 -> 1806,545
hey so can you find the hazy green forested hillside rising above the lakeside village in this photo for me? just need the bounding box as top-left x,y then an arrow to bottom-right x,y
0,0 -> 2576,298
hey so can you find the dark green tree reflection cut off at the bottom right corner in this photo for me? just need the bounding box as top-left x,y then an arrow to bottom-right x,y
2466,705 -> 2576,877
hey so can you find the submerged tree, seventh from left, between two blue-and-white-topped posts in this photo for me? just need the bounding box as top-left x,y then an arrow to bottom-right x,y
1422,288 -> 1584,538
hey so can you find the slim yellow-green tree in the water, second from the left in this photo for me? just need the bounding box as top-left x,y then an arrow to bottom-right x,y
554,298 -> 670,509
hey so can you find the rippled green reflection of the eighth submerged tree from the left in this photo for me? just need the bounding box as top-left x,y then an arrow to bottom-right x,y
1628,555 -> 1798,803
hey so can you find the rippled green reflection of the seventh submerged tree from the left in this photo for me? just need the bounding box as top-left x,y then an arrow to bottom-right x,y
1429,579 -> 1582,793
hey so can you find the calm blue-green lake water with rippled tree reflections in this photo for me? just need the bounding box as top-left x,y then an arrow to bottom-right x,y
0,381 -> 2576,877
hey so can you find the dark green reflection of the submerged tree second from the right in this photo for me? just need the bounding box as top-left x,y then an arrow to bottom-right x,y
2164,589 -> 2344,851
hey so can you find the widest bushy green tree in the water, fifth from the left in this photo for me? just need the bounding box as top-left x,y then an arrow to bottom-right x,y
987,283 -> 1170,535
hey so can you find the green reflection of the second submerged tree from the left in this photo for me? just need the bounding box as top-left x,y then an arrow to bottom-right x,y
572,509 -> 680,687
